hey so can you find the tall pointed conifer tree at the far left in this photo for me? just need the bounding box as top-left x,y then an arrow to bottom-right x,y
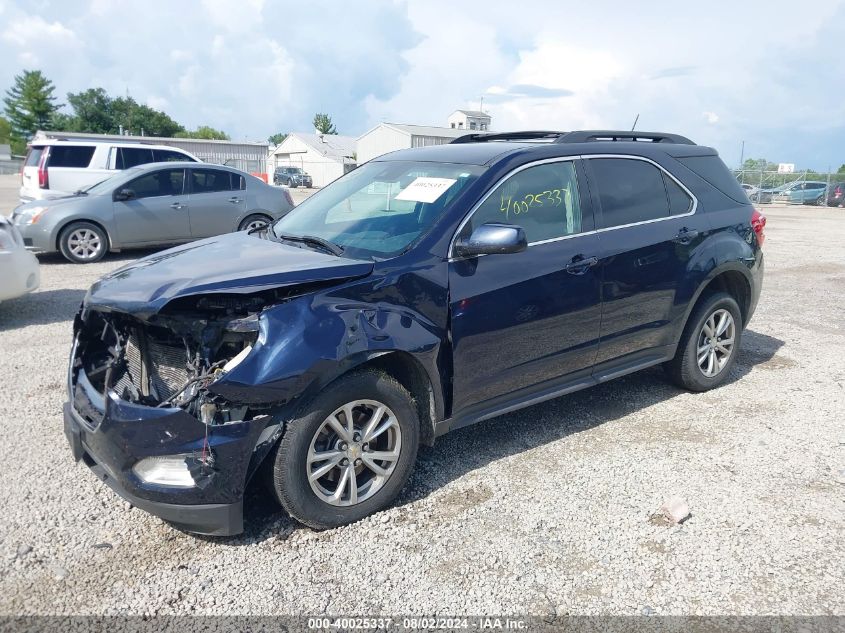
3,70 -> 60,141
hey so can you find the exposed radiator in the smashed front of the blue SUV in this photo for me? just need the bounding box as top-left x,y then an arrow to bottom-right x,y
114,329 -> 191,402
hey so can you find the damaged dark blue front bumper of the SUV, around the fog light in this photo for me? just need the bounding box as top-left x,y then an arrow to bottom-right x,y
64,362 -> 268,536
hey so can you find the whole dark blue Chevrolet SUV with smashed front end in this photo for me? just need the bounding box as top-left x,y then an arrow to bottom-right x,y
64,131 -> 765,535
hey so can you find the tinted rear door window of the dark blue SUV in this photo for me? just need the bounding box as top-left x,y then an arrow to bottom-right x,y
590,158 -> 669,228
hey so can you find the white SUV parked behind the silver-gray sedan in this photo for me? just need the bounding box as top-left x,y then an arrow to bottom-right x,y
20,138 -> 200,202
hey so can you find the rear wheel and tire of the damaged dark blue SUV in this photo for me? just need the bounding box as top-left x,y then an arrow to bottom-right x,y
663,292 -> 742,391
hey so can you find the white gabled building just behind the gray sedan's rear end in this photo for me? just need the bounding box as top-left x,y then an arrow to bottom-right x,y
268,132 -> 356,187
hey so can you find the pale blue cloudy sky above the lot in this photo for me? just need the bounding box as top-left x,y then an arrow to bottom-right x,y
0,0 -> 845,170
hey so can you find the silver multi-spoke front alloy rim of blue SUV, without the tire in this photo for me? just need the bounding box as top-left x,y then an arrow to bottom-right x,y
305,400 -> 402,506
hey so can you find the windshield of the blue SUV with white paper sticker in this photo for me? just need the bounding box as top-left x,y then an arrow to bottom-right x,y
273,161 -> 484,258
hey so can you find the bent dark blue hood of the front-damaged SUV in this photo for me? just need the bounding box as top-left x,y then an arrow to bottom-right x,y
85,232 -> 373,318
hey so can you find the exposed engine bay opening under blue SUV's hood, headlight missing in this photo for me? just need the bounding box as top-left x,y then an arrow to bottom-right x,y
74,295 -> 266,424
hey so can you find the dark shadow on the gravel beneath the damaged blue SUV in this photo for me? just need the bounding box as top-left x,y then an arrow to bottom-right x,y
198,330 -> 784,546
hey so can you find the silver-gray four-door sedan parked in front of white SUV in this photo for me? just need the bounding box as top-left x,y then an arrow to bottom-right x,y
12,162 -> 293,264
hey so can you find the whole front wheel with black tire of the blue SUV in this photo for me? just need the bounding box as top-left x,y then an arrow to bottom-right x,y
270,371 -> 419,529
